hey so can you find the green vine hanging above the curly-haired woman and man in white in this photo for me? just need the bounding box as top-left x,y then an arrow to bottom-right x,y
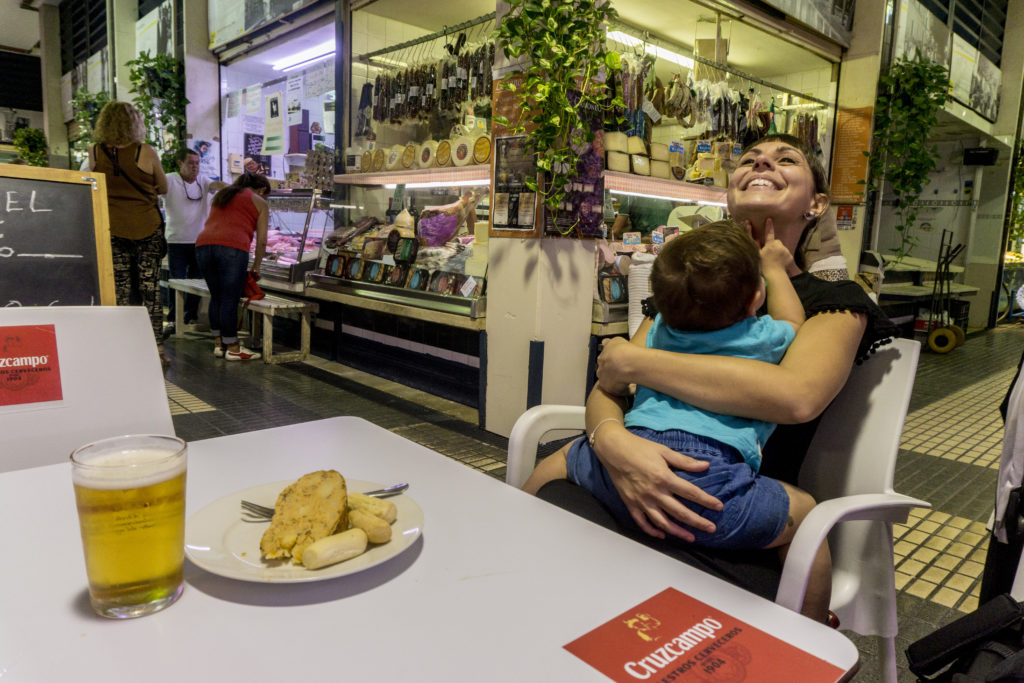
127,51 -> 188,172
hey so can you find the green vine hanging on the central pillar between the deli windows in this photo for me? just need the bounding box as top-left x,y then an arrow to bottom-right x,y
495,0 -> 623,233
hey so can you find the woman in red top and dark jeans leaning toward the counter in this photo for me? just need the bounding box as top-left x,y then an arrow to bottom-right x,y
196,173 -> 270,360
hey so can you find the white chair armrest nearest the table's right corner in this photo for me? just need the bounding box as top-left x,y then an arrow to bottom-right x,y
775,494 -> 932,611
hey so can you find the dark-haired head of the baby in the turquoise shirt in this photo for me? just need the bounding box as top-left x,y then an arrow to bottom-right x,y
650,220 -> 761,332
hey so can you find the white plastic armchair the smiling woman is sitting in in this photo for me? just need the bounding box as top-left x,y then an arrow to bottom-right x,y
506,339 -> 931,681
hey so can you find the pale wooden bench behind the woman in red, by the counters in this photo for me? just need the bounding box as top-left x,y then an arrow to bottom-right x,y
167,280 -> 319,362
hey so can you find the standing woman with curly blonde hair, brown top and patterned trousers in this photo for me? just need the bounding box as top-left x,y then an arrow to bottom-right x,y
89,100 -> 170,368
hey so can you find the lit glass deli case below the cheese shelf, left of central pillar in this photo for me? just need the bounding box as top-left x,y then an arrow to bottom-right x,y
306,165 -> 489,321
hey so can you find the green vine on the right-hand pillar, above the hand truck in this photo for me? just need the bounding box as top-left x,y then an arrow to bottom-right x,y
864,50 -> 950,262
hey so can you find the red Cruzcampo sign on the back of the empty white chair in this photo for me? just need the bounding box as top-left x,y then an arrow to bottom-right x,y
0,325 -> 63,405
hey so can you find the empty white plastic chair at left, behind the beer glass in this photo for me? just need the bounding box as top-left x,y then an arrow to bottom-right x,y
0,306 -> 174,472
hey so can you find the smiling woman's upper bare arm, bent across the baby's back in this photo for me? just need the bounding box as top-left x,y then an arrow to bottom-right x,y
597,311 -> 867,424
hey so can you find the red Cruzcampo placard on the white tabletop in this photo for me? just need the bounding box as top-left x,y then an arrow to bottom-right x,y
565,588 -> 845,683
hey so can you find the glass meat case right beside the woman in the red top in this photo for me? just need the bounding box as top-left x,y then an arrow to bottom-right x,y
253,189 -> 334,284
